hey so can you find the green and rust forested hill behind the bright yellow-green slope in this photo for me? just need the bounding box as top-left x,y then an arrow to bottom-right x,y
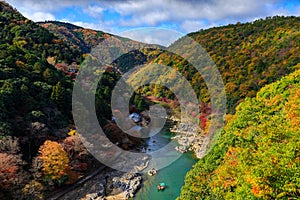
153,17 -> 300,112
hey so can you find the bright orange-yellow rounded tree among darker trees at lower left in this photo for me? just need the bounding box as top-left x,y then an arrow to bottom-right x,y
39,140 -> 69,180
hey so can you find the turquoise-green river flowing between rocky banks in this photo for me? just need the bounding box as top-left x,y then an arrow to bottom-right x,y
134,128 -> 197,200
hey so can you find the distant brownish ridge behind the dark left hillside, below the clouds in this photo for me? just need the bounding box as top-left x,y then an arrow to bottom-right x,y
38,21 -> 160,72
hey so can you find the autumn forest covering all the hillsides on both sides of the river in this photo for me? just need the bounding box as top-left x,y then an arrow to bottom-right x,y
0,2 -> 300,199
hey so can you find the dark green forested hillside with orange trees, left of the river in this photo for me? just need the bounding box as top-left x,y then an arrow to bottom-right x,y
0,2 -> 145,199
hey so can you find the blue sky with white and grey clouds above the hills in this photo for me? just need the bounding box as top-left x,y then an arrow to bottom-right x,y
7,0 -> 300,44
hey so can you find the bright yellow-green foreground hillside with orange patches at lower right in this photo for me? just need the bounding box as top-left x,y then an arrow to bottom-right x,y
178,67 -> 300,200
